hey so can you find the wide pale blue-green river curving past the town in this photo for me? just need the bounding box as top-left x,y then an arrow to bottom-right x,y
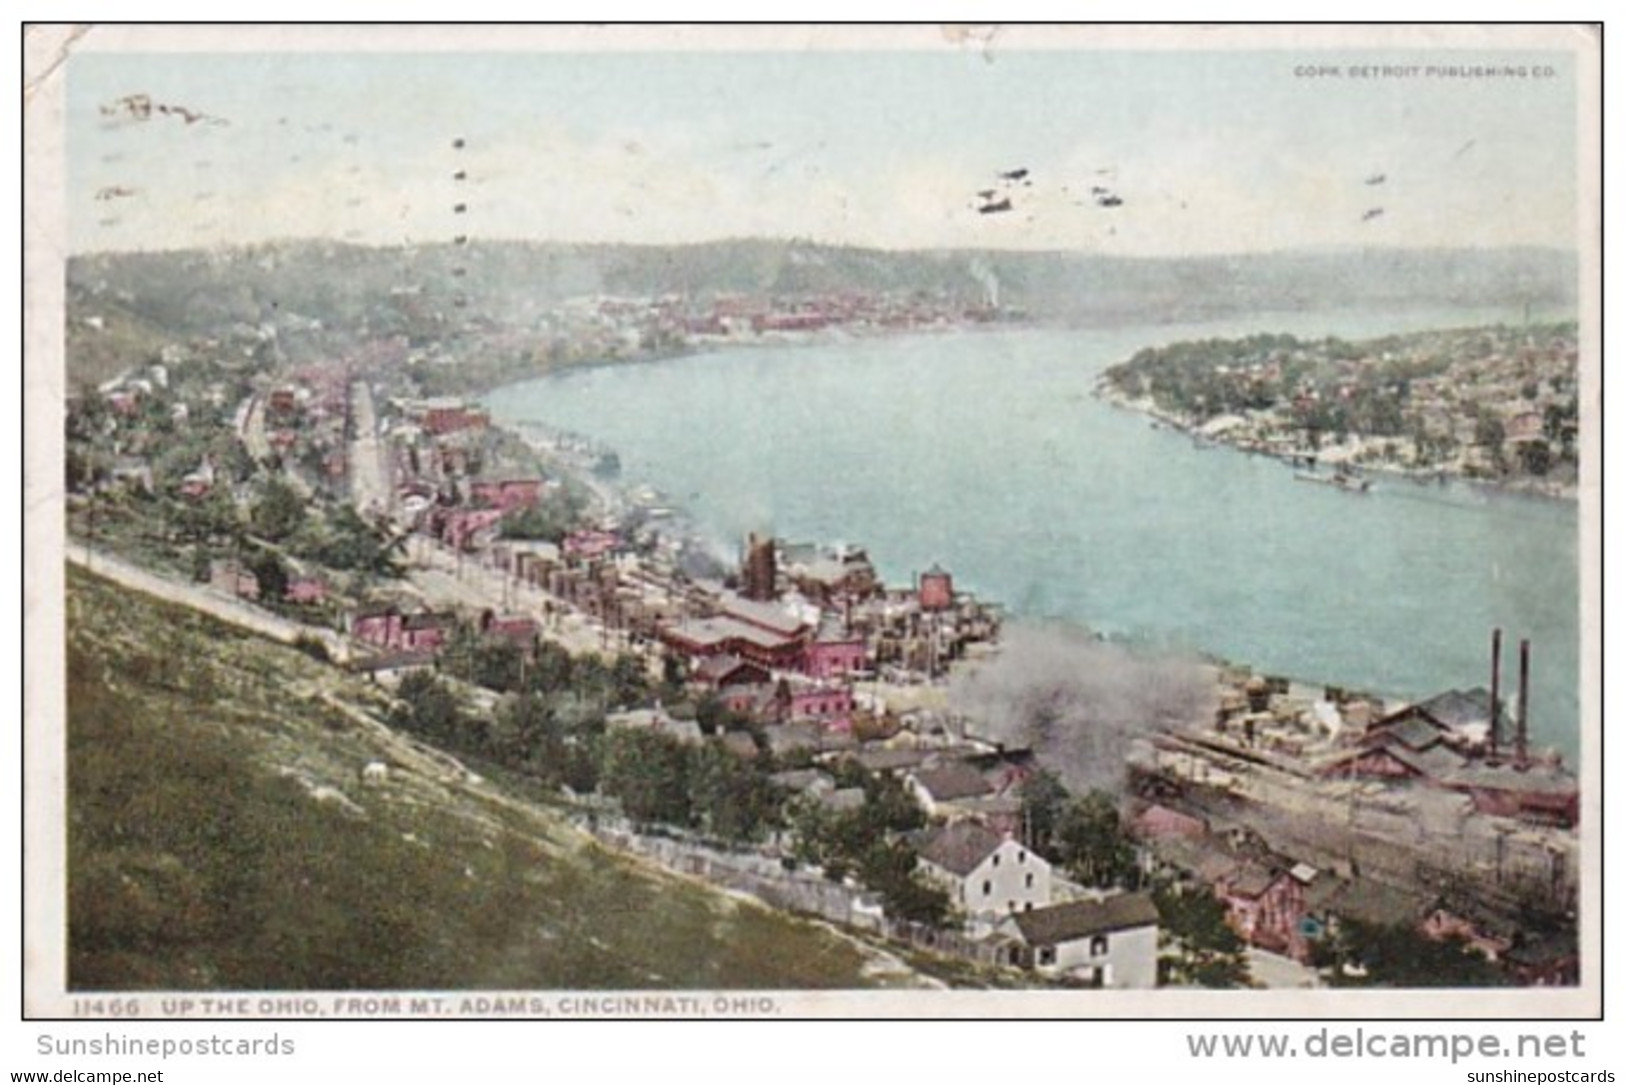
488,310 -> 1580,763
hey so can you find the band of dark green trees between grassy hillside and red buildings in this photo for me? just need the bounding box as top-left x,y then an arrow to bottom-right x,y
390,656 -> 949,923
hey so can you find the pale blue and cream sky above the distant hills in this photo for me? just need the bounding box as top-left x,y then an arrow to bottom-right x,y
54,28 -> 1581,257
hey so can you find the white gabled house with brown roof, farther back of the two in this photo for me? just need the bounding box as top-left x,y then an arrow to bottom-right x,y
920,820 -> 1050,919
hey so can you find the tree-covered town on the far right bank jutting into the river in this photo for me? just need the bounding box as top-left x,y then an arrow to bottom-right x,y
1097,322 -> 1580,500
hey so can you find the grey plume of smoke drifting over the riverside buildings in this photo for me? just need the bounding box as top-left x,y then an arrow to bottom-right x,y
949,625 -> 1216,791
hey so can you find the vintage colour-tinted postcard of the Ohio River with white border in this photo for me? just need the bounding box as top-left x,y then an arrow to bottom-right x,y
21,24 -> 1602,1026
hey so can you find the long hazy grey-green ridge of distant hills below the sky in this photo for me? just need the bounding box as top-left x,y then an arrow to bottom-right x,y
68,240 -> 1578,335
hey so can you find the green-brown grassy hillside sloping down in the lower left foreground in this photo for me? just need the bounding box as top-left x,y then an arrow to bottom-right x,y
67,568 -> 912,989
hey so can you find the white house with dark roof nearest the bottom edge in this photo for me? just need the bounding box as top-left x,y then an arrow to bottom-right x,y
999,893 -> 1157,988
